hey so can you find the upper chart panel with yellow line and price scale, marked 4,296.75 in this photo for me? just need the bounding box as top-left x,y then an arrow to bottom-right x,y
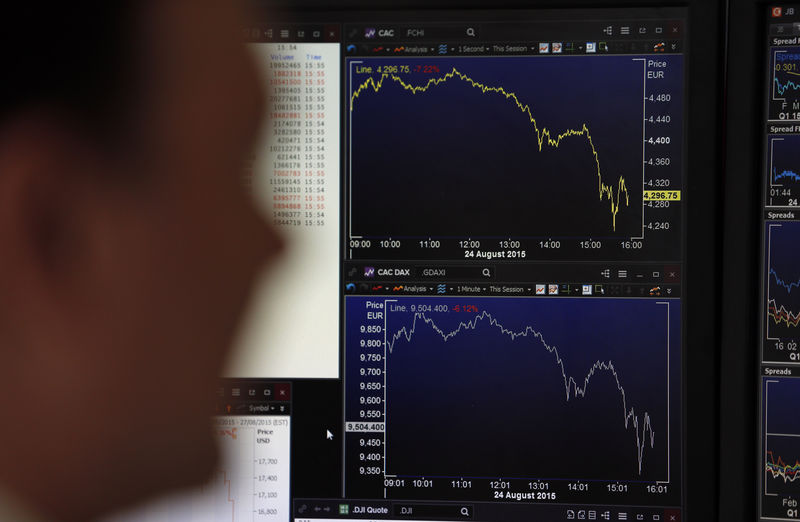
345,50 -> 683,259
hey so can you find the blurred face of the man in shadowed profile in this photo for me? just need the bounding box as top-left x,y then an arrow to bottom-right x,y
0,0 -> 280,519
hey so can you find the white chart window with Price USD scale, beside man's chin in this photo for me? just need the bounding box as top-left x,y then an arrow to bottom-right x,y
106,380 -> 291,522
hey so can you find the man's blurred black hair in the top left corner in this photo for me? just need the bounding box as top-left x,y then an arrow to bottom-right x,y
0,4 -> 138,132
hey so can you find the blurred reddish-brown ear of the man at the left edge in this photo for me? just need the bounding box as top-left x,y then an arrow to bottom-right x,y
0,114 -> 98,314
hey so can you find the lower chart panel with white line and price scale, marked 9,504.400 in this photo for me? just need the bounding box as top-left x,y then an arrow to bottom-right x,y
345,296 -> 681,503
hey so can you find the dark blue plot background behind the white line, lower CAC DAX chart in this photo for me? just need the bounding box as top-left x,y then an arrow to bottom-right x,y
347,297 -> 680,480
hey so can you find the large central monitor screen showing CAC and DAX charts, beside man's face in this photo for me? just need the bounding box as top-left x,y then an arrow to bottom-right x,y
109,7 -> 692,522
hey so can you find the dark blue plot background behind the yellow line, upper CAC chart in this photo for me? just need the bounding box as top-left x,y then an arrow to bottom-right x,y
346,56 -> 682,237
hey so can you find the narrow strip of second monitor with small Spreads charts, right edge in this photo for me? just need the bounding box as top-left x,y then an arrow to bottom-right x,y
759,5 -> 800,520
